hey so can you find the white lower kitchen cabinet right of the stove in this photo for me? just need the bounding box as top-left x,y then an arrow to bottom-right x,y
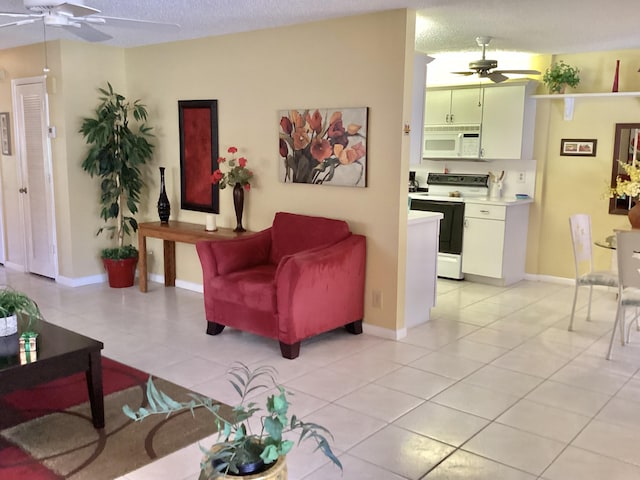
462,201 -> 529,285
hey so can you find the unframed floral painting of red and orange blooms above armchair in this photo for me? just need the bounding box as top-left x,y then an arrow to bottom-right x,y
278,107 -> 368,187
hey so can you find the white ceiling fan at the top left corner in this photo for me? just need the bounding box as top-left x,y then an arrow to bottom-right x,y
0,0 -> 180,42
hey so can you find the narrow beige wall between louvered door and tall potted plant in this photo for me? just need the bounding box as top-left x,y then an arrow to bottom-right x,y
57,42 -> 127,278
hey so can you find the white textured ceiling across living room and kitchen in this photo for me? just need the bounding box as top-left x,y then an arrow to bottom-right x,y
0,0 -> 640,54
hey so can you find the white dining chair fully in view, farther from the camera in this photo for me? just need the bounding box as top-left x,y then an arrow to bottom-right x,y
569,213 -> 618,332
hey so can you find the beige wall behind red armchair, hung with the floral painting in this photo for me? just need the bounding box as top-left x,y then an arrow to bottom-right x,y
121,10 -> 415,329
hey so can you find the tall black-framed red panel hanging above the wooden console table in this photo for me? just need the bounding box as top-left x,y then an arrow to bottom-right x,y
178,100 -> 220,213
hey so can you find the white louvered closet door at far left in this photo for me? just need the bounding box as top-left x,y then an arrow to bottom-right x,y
14,78 -> 57,278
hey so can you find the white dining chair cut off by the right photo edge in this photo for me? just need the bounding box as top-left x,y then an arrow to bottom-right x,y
607,230 -> 640,360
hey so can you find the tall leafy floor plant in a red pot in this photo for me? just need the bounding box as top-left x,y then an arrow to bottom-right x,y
80,83 -> 153,288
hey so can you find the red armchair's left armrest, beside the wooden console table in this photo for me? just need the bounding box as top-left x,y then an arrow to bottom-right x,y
196,228 -> 271,278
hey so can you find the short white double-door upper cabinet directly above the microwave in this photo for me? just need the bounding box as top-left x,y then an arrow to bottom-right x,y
424,87 -> 482,125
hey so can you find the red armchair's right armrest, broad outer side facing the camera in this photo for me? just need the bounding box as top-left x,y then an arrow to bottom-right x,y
275,235 -> 366,344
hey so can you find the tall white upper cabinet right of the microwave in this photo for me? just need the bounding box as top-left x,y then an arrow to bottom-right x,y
480,81 -> 536,160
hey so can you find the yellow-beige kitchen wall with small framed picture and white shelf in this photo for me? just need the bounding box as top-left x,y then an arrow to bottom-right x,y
527,50 -> 640,278
